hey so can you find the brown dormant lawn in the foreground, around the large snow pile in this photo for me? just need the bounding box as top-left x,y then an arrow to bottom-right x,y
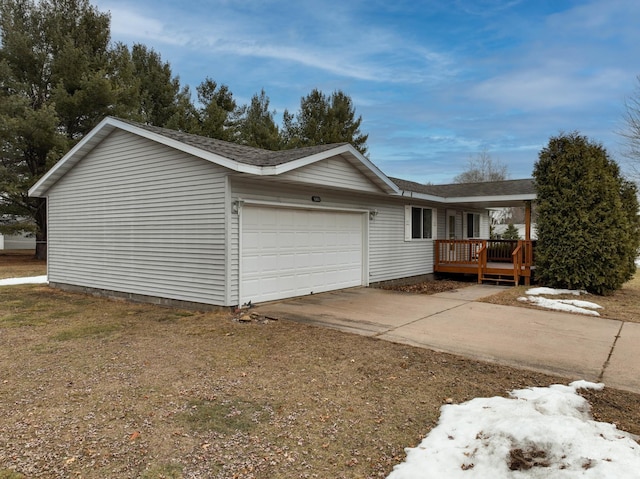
0,256 -> 640,479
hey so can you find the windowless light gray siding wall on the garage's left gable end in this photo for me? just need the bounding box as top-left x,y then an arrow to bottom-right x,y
48,130 -> 226,305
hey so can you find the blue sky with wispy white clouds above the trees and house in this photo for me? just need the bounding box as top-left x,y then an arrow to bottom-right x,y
92,0 -> 640,183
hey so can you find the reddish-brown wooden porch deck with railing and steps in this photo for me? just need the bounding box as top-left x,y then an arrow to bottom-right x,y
434,239 -> 535,285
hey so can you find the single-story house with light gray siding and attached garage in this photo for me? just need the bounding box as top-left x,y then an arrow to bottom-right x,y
29,117 -> 535,306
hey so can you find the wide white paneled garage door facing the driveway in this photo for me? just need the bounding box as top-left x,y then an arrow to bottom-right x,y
241,206 -> 364,304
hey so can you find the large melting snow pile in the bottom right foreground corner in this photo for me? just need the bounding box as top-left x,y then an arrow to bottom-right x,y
387,381 -> 640,479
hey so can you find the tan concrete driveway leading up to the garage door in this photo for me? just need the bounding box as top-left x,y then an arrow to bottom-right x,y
255,285 -> 640,393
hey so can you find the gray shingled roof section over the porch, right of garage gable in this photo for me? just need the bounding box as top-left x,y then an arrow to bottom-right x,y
390,178 -> 536,198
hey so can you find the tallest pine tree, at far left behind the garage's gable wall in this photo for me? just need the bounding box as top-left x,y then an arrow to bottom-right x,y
0,0 -> 118,258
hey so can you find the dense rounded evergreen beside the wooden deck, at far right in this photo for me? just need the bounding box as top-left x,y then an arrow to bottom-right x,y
533,133 -> 639,294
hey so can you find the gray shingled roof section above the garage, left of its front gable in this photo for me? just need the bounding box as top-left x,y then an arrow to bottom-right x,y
121,120 -> 345,166
